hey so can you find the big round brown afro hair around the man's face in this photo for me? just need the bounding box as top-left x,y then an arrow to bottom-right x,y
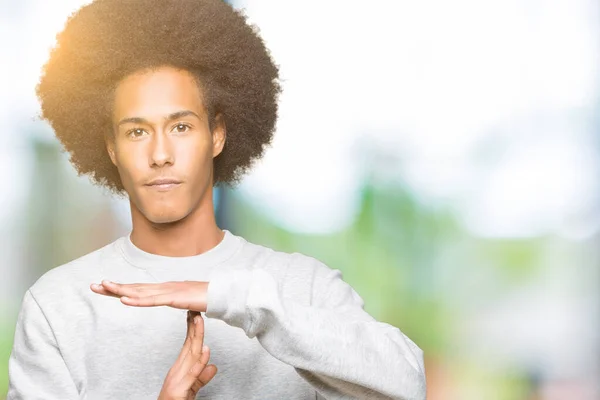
36,0 -> 281,195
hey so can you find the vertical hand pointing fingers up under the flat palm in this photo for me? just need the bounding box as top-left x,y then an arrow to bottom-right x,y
158,311 -> 217,400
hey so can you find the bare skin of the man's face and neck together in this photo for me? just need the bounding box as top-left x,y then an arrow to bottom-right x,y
107,67 -> 226,257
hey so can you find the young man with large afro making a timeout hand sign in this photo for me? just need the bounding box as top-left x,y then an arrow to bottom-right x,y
8,0 -> 425,400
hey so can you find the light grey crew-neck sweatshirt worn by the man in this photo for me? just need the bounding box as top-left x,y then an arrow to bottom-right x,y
8,231 -> 425,400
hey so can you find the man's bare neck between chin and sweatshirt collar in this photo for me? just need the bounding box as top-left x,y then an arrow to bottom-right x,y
130,187 -> 225,257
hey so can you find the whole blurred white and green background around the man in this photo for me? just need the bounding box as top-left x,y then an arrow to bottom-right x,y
0,0 -> 600,400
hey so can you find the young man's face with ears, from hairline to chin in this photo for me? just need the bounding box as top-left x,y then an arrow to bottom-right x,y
107,67 -> 225,223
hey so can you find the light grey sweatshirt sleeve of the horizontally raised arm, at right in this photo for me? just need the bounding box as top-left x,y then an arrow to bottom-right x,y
206,257 -> 426,400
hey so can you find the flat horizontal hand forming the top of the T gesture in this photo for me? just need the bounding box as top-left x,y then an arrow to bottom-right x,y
90,280 -> 208,312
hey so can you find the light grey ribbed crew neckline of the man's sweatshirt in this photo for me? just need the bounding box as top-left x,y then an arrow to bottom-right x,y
117,229 -> 243,270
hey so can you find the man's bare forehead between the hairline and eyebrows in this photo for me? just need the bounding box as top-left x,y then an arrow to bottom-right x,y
113,67 -> 204,120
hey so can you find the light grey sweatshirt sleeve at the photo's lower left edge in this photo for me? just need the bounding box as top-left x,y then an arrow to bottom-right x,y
7,290 -> 79,400
